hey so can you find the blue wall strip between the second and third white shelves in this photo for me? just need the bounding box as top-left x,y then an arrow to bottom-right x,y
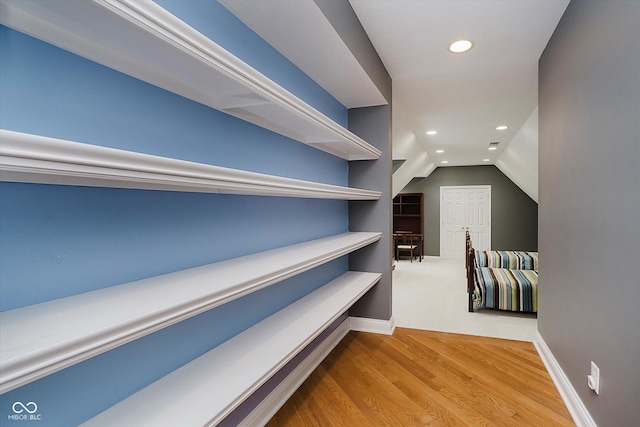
0,183 -> 347,310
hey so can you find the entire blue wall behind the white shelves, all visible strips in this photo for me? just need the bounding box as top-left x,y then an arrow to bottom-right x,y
0,0 -> 348,426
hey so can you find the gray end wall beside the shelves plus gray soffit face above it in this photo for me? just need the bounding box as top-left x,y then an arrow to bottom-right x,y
314,0 -> 392,320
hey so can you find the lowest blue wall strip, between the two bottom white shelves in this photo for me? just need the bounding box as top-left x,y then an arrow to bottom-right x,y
0,258 -> 346,427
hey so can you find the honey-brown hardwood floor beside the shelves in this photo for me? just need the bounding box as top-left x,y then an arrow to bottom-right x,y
267,328 -> 575,427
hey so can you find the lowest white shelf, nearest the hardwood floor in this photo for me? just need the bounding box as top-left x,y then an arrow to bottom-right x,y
82,272 -> 380,426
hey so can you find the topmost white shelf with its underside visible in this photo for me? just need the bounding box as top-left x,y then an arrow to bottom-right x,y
0,0 -> 381,160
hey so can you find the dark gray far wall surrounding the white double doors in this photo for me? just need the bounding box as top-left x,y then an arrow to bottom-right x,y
401,166 -> 538,256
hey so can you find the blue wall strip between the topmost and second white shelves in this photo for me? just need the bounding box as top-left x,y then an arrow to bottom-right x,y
0,26 -> 348,185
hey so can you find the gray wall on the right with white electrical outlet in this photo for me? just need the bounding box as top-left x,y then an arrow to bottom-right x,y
538,0 -> 640,427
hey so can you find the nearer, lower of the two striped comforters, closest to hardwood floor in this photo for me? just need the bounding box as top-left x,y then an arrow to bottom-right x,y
474,267 -> 538,313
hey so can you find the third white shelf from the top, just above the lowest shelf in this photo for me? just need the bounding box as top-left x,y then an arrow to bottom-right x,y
0,232 -> 381,393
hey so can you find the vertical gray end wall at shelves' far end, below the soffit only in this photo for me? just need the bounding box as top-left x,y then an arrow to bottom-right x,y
349,105 -> 391,320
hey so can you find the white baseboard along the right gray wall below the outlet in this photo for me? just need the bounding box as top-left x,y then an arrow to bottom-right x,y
533,331 -> 597,427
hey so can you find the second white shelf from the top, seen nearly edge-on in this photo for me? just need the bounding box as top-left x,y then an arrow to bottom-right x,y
0,129 -> 380,200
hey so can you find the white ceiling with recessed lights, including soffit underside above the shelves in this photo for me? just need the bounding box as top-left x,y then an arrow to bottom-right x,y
220,0 -> 569,172
